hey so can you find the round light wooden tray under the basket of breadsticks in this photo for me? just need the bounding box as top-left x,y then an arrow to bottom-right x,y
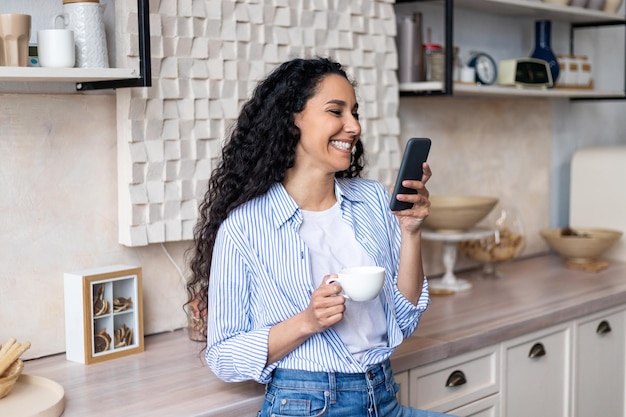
0,374 -> 65,417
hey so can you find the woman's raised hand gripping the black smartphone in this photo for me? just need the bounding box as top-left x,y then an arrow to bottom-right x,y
393,162 -> 432,233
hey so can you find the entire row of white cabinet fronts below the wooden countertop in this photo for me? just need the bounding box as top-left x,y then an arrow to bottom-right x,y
395,306 -> 626,417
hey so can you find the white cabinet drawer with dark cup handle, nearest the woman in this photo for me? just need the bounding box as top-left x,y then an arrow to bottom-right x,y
409,346 -> 499,412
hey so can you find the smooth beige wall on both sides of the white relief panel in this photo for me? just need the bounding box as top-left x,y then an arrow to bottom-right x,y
0,95 -> 551,356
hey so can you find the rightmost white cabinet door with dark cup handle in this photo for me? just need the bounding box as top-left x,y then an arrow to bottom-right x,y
572,308 -> 626,417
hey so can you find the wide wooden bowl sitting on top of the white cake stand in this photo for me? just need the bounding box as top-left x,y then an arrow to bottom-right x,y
424,195 -> 498,233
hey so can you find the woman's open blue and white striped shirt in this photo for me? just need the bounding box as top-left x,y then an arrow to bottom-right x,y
206,178 -> 430,383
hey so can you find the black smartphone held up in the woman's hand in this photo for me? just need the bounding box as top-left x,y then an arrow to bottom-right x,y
389,138 -> 430,211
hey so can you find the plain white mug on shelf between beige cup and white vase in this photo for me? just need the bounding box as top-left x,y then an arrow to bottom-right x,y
37,29 -> 75,68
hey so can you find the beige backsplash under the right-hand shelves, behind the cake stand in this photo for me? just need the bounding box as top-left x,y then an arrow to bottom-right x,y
400,97 -> 552,275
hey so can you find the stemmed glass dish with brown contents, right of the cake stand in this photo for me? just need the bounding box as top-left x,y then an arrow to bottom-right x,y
459,207 -> 526,279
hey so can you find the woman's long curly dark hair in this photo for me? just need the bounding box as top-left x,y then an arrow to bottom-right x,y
185,58 -> 364,337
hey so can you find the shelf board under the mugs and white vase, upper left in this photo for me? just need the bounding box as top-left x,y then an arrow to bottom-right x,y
0,67 -> 139,83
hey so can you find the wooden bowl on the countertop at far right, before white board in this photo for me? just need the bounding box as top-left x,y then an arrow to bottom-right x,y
539,227 -> 622,264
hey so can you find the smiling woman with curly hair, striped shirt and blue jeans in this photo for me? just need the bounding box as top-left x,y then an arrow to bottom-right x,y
188,58 -> 448,417
